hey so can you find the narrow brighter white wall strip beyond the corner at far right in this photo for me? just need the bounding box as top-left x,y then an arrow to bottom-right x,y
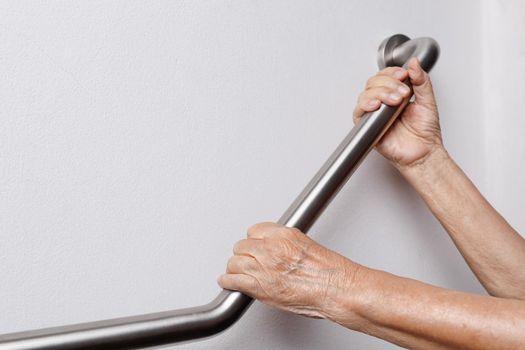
483,0 -> 525,228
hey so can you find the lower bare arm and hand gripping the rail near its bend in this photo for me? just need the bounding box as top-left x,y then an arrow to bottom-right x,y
219,223 -> 525,350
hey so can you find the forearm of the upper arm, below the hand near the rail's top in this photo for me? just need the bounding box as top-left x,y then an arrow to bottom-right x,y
399,148 -> 525,299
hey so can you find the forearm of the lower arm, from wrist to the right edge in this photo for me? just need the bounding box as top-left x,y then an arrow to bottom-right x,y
323,267 -> 525,349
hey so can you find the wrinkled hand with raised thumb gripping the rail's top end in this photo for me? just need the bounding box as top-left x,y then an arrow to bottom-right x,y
353,58 -> 443,168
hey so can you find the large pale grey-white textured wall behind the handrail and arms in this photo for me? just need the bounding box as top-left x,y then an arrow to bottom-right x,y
0,0 -> 525,349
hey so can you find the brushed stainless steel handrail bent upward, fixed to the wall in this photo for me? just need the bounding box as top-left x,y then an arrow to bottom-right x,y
0,34 -> 439,350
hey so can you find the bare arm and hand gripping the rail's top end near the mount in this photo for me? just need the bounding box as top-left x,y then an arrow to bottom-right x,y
354,56 -> 525,299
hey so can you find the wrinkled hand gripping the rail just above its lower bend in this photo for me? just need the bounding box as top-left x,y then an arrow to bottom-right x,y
218,223 -> 357,318
